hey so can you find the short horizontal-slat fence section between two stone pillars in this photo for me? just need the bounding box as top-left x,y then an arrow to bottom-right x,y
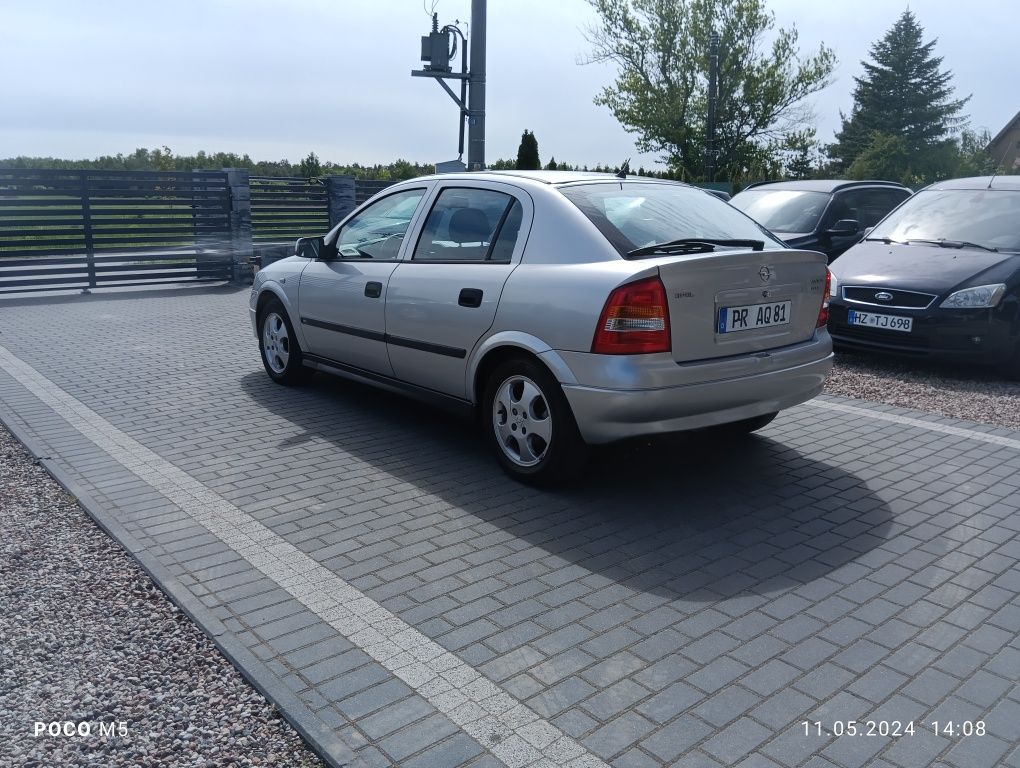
249,176 -> 329,244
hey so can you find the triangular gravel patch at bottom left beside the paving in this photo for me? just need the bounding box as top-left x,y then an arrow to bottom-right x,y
0,425 -> 322,768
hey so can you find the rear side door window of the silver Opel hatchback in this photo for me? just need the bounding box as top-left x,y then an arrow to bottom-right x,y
414,188 -> 523,261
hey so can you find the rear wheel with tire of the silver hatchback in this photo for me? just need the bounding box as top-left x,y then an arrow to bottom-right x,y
481,358 -> 588,485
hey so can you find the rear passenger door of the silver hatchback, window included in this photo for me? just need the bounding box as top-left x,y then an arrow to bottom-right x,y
386,181 -> 532,398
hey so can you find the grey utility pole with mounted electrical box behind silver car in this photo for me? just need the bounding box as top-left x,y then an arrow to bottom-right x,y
411,0 -> 486,170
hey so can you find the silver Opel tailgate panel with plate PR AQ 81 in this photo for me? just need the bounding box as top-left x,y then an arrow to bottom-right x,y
658,250 -> 826,362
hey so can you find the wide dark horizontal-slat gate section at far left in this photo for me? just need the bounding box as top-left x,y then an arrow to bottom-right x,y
0,169 -> 233,293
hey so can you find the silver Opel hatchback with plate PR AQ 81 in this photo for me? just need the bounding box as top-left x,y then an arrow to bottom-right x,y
250,171 -> 832,482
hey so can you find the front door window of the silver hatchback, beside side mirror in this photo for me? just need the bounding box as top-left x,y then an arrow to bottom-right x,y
326,190 -> 425,261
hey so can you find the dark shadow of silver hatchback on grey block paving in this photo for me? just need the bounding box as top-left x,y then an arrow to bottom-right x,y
241,372 -> 891,603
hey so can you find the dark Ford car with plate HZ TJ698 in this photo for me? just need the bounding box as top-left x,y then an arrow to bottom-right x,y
828,176 -> 1020,378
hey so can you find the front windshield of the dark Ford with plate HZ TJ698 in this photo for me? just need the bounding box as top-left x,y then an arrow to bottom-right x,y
868,190 -> 1020,251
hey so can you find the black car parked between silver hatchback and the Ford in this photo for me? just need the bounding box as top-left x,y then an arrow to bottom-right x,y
729,180 -> 911,263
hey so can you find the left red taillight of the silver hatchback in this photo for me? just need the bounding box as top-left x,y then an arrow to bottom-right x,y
592,276 -> 670,355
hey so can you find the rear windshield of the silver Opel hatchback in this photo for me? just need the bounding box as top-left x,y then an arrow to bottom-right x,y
560,182 -> 785,256
